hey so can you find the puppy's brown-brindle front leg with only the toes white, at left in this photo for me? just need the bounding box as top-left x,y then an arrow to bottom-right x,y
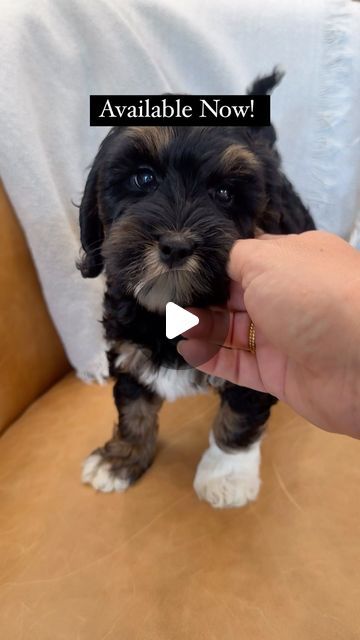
82,373 -> 162,492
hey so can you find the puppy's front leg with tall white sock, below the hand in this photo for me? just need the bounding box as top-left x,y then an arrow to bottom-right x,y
194,384 -> 276,508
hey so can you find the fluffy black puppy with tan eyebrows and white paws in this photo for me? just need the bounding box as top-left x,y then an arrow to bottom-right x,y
78,70 -> 314,507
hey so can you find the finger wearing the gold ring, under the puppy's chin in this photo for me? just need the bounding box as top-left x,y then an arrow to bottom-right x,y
182,308 -> 250,349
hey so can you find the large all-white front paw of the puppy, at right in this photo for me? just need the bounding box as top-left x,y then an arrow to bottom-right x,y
194,438 -> 260,509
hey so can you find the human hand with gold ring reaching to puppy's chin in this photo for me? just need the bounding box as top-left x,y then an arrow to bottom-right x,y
178,231 -> 360,437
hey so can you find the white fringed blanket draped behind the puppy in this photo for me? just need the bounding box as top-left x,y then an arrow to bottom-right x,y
0,0 -> 360,380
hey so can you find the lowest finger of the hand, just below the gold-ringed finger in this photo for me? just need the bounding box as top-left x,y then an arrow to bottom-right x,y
177,340 -> 266,392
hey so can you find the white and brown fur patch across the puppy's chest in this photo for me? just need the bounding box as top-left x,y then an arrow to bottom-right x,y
111,341 -> 223,401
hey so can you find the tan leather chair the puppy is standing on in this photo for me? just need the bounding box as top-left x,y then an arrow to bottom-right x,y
0,182 -> 360,640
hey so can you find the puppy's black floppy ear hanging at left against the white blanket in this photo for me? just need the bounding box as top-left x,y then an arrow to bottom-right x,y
76,154 -> 104,278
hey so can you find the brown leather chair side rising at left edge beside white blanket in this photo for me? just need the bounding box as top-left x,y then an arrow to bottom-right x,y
0,182 -> 70,431
